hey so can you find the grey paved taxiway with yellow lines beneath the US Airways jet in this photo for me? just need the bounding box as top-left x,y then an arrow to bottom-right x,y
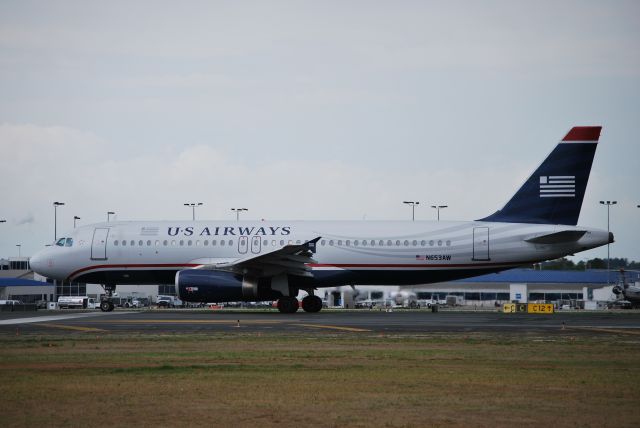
0,310 -> 640,338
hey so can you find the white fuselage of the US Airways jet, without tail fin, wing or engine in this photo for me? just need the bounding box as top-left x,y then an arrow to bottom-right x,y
31,221 -> 609,287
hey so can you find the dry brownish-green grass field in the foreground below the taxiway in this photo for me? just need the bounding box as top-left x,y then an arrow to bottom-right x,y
0,333 -> 640,427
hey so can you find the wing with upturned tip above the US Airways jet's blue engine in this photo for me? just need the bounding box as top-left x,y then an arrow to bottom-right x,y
190,237 -> 320,277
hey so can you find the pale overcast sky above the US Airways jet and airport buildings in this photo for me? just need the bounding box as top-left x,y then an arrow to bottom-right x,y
0,0 -> 640,261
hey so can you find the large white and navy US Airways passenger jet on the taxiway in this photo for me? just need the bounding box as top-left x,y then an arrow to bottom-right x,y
30,126 -> 613,313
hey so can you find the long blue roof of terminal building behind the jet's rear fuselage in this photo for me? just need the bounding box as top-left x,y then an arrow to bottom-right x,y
456,269 -> 618,284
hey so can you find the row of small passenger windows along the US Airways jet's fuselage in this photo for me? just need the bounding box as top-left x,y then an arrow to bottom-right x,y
115,239 -> 451,247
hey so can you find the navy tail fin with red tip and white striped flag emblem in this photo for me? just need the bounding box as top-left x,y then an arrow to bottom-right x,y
479,126 -> 602,225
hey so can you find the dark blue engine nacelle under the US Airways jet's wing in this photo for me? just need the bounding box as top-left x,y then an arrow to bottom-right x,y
176,269 -> 280,302
